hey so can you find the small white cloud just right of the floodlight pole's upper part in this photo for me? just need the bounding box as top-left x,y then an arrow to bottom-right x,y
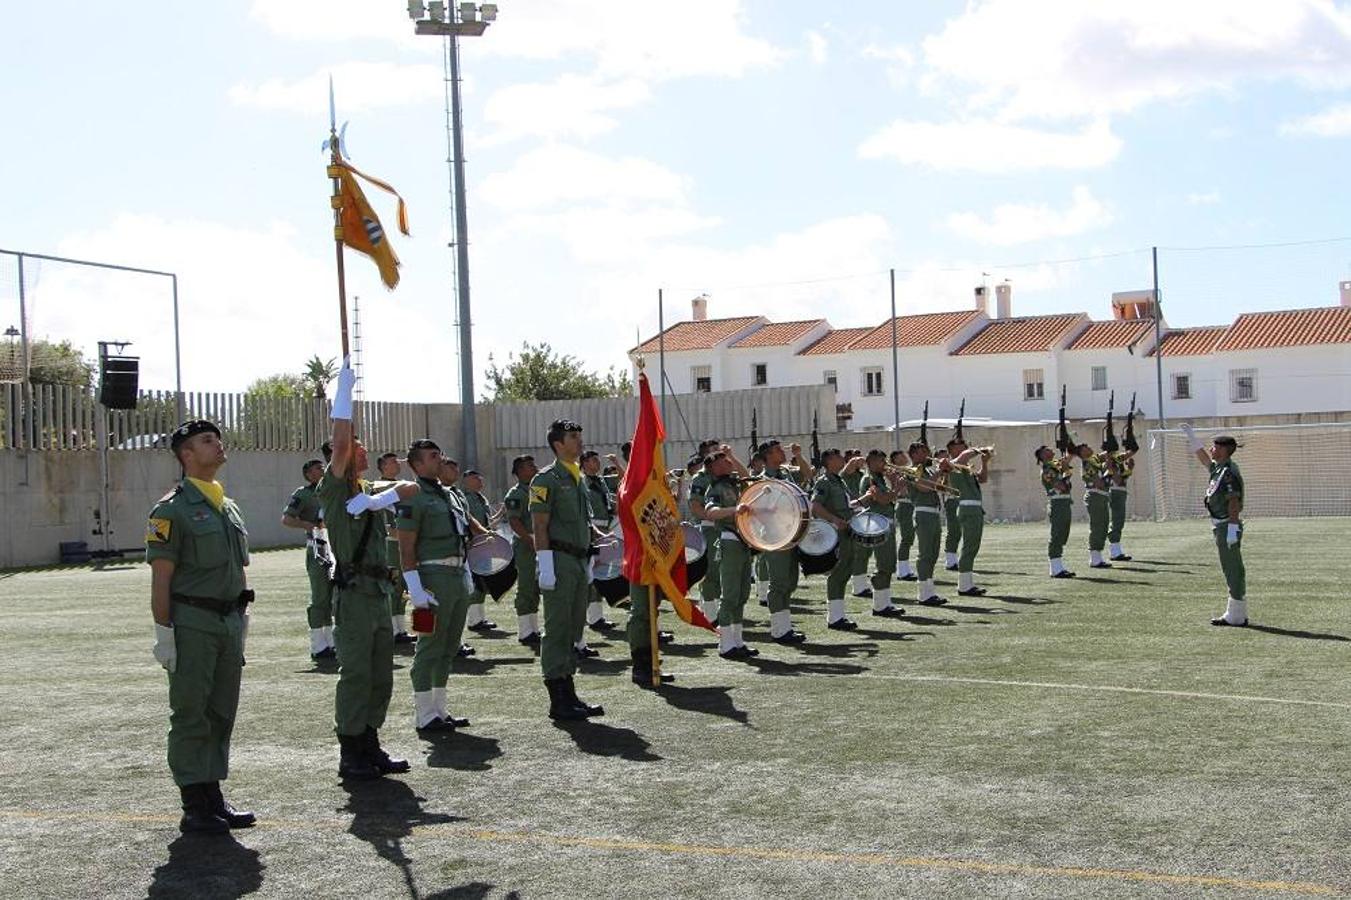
484,74 -> 651,145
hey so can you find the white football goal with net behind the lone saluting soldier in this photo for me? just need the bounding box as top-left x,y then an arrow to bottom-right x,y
1148,422 -> 1351,519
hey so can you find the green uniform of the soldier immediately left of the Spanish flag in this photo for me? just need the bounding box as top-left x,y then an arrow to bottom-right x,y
530,461 -> 592,680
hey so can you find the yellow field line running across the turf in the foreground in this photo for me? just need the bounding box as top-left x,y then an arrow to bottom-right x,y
0,809 -> 1343,896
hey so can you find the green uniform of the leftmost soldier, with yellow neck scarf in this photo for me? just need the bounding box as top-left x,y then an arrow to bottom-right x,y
146,478 -> 249,786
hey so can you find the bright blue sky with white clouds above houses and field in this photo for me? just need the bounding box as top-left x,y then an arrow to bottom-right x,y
0,0 -> 1351,400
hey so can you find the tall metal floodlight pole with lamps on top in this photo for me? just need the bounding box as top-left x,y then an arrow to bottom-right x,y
408,0 -> 497,468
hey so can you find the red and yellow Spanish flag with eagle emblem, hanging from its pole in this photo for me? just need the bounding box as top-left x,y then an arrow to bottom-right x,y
619,372 -> 716,631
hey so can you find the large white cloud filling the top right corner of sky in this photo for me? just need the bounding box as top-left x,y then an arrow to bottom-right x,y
923,0 -> 1351,122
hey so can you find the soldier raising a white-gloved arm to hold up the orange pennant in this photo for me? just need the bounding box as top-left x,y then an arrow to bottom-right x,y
319,359 -> 420,778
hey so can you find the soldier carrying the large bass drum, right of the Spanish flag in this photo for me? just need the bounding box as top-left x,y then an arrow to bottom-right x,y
704,445 -> 759,659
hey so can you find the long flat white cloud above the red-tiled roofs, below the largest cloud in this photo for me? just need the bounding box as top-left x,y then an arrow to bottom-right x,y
858,120 -> 1121,173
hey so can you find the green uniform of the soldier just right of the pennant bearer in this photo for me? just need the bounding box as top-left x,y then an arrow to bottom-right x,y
394,477 -> 473,695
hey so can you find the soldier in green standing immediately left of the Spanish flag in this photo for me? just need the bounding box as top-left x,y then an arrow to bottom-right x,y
530,419 -> 605,720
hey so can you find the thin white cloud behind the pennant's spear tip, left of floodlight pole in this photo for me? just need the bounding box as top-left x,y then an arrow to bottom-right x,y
230,62 -> 443,118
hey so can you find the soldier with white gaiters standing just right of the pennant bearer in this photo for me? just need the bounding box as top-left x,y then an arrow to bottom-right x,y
394,439 -> 482,731
